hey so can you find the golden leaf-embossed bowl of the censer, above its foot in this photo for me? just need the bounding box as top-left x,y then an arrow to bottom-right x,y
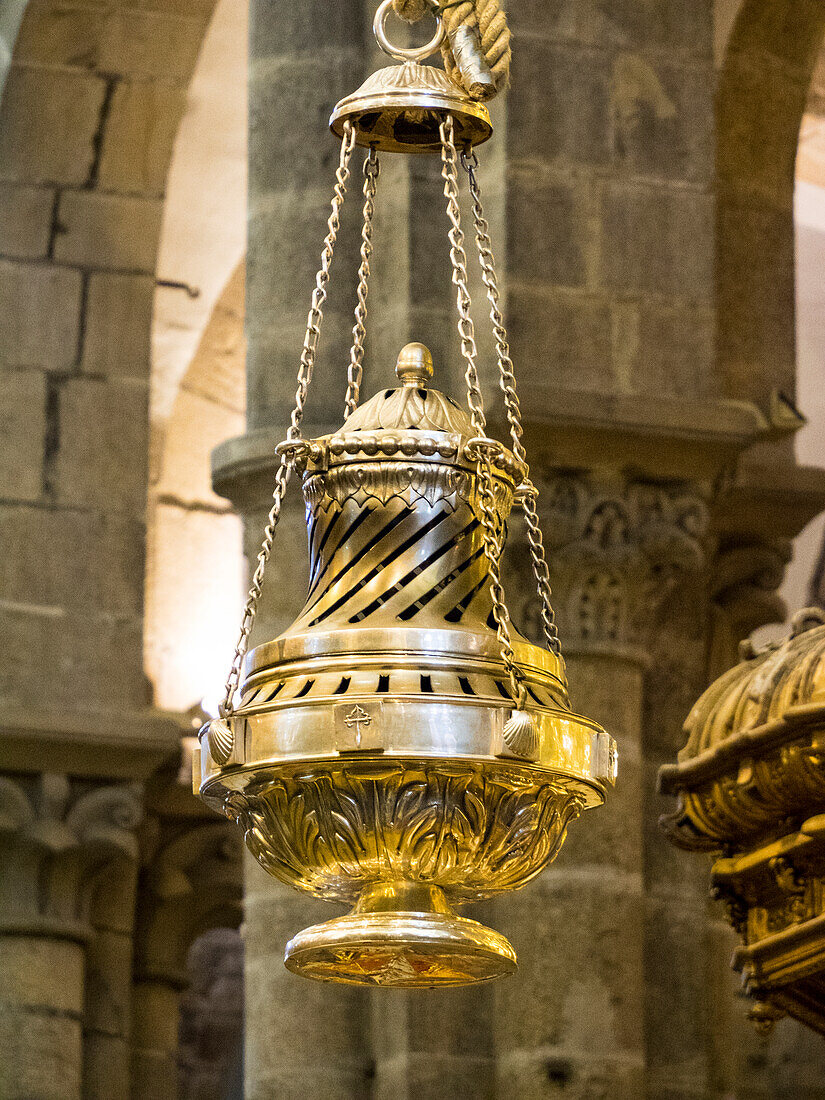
224,761 -> 582,904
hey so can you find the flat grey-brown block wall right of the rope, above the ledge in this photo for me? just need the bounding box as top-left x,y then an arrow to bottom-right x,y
506,0 -> 718,397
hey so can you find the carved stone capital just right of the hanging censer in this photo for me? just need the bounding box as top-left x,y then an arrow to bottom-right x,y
523,474 -> 708,648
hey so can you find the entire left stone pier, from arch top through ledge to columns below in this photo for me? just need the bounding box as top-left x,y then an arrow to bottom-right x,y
0,0 -> 248,1100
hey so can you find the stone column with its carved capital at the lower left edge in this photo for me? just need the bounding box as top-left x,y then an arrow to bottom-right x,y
0,774 -> 142,1100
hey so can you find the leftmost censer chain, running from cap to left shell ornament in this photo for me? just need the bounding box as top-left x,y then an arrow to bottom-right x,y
220,122 -> 355,717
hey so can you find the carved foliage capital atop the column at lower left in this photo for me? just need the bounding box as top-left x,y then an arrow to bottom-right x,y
0,774 -> 143,937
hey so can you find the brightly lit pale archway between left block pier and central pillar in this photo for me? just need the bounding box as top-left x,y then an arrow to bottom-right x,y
144,0 -> 248,711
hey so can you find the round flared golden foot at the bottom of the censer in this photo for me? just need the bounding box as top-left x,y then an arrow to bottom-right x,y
284,884 -> 517,989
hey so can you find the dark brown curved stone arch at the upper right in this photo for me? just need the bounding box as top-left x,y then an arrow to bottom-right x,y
716,0 -> 825,406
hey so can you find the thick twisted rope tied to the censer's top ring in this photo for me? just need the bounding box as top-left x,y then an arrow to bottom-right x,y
393,0 -> 510,99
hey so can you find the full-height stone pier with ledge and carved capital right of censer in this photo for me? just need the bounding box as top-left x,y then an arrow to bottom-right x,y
497,0 -> 748,1100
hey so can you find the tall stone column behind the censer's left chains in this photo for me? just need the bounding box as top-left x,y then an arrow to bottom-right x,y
235,0 -> 374,1100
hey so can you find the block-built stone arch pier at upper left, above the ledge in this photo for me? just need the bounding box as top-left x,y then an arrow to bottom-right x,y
0,0 -> 223,711
